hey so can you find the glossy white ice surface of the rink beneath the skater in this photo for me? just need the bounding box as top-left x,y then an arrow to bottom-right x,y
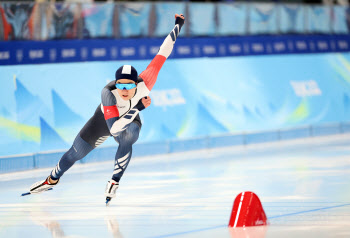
0,134 -> 350,238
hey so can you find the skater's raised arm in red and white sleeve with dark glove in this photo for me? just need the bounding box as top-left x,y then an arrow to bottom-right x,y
140,14 -> 185,91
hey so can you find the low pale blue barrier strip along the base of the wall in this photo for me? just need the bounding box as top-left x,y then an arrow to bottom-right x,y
0,122 -> 350,173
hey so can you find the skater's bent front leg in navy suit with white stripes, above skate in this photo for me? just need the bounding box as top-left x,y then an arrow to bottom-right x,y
112,122 -> 140,182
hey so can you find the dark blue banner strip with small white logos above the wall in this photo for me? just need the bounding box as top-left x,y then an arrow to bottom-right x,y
0,35 -> 350,65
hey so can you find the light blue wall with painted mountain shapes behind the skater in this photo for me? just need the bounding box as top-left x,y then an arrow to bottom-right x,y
0,53 -> 350,155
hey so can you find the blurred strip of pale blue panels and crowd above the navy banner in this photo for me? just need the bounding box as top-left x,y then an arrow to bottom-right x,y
0,0 -> 350,41
